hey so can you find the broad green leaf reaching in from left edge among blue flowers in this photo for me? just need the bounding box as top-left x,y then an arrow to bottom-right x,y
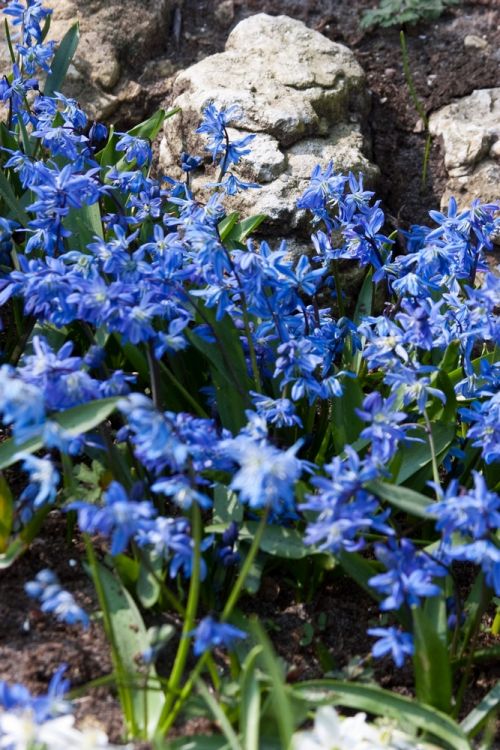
0,397 -> 120,471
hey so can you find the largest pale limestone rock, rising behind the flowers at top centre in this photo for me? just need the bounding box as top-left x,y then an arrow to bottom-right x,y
160,13 -> 378,235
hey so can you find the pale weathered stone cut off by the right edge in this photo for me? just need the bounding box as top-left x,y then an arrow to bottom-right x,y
429,88 -> 500,210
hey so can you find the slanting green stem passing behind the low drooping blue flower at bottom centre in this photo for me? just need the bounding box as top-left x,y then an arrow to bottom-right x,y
158,508 -> 269,737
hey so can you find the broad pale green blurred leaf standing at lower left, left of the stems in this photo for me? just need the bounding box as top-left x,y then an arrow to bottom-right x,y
89,563 -> 164,737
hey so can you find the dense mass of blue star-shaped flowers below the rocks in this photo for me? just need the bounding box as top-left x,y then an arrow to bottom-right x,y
0,0 -> 500,688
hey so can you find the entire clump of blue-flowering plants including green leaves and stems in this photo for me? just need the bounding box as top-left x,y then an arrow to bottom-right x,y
0,0 -> 500,750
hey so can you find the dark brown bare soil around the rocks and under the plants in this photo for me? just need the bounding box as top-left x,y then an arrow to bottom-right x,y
0,0 -> 500,741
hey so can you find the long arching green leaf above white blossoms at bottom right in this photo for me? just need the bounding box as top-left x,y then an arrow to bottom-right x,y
293,680 -> 471,750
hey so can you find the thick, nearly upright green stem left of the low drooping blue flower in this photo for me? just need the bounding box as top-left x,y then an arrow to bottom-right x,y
158,503 -> 202,728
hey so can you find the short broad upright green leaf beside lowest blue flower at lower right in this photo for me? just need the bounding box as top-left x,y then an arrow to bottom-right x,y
412,607 -> 452,713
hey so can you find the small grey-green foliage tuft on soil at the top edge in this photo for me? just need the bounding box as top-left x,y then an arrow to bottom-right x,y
361,0 -> 459,29
